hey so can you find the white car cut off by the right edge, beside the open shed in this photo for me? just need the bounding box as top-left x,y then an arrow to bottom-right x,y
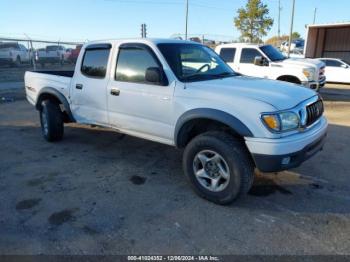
320,58 -> 350,84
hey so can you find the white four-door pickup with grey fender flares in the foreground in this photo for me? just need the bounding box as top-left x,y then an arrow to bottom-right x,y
25,39 -> 327,204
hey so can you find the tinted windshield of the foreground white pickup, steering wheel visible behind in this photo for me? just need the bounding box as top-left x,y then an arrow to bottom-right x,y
158,43 -> 237,82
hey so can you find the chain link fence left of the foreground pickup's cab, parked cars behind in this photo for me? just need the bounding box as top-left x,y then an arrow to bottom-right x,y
0,37 -> 83,83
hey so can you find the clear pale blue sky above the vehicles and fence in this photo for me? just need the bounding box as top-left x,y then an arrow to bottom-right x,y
0,0 -> 350,41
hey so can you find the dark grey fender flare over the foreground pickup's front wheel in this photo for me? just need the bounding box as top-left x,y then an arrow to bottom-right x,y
174,108 -> 253,145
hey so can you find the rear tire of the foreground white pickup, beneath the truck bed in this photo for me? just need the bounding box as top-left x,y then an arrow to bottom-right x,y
40,100 -> 64,142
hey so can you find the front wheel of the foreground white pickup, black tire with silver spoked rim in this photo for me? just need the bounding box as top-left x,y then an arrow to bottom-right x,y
183,131 -> 254,205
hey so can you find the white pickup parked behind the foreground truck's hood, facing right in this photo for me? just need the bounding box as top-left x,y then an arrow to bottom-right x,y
215,43 -> 326,91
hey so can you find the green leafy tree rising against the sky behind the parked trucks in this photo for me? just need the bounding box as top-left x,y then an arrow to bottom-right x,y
234,0 -> 273,43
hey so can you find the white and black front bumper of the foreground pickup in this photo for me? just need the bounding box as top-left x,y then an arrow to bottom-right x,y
246,117 -> 328,172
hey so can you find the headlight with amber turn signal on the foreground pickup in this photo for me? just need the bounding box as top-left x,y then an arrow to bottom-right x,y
261,112 -> 300,132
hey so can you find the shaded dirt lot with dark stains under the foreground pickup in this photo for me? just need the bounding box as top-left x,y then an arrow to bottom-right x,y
0,87 -> 350,254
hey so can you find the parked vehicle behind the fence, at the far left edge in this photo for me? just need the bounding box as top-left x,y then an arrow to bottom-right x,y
0,42 -> 31,66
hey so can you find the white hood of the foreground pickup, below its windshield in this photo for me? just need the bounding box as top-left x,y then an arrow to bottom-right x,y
186,76 -> 316,110
